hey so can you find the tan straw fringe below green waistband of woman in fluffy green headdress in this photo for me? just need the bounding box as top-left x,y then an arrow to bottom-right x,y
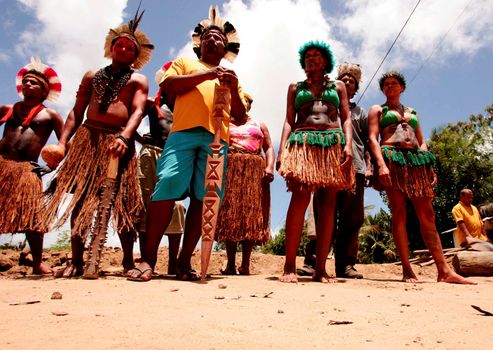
279,135 -> 355,192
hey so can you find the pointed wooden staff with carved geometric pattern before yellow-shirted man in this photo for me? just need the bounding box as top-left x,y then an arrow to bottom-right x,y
200,84 -> 231,282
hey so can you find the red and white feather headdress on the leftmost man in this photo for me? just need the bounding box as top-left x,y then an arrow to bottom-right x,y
15,57 -> 62,102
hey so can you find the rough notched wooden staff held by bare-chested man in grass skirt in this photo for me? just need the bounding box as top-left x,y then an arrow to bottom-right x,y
82,155 -> 119,279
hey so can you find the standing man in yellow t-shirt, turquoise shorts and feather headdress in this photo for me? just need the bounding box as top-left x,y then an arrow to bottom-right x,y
127,8 -> 246,281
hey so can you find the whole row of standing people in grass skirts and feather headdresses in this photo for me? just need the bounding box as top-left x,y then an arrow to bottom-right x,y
0,7 -> 482,283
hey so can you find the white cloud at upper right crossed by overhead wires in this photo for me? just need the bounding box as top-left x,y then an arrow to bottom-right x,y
338,0 -> 493,82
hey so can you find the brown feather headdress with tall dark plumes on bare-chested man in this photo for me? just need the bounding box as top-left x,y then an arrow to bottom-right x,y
104,4 -> 154,69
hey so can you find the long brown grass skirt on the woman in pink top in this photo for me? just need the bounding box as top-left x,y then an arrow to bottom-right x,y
216,152 -> 270,244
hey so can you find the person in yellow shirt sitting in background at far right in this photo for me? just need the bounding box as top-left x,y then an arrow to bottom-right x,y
452,188 -> 487,250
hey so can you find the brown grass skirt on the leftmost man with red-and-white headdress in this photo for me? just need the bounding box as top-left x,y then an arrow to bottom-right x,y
0,156 -> 48,233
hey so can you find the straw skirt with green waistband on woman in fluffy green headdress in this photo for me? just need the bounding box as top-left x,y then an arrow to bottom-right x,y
279,129 -> 355,192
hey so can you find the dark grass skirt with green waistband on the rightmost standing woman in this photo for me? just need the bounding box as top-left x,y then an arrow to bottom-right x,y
373,146 -> 435,198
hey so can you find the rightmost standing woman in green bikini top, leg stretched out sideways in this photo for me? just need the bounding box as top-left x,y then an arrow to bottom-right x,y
368,71 -> 470,283
